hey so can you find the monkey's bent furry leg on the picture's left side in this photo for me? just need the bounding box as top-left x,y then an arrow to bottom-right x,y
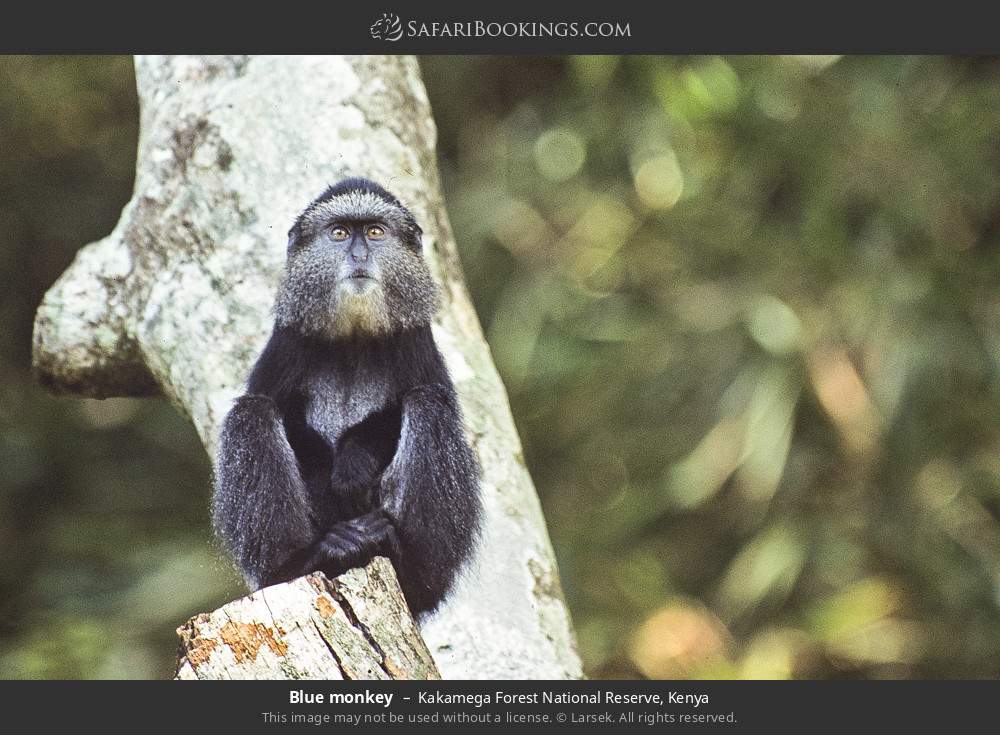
212,394 -> 315,588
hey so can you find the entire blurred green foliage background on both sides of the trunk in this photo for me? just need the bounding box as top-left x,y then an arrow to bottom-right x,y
0,56 -> 1000,678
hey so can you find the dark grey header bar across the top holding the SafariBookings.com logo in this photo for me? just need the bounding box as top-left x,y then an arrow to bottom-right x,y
0,0 -> 1000,54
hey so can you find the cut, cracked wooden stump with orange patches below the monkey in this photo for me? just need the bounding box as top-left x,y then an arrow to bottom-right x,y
176,557 -> 441,679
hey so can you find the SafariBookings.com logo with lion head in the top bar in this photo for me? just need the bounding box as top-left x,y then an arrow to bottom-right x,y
368,13 -> 632,41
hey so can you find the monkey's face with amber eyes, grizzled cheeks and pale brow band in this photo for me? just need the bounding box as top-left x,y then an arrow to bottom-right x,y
276,192 -> 437,339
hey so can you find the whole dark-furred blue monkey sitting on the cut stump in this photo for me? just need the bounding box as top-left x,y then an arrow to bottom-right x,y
213,179 -> 481,615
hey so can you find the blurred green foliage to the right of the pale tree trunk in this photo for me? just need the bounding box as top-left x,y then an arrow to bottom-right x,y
423,56 -> 1000,677
